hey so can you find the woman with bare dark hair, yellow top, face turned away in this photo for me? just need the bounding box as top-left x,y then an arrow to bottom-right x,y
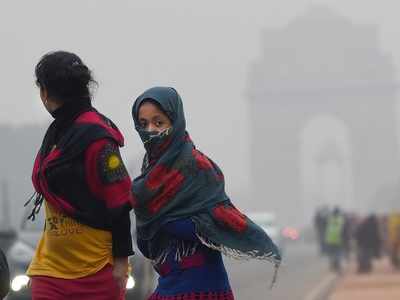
27,51 -> 133,300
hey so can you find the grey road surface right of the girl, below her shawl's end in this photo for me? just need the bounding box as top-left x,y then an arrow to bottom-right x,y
225,242 -> 331,300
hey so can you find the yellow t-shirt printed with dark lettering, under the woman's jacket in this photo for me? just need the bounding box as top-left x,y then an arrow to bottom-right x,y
27,201 -> 113,279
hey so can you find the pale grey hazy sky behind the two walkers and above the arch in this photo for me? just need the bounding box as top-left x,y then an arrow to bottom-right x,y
0,0 -> 400,202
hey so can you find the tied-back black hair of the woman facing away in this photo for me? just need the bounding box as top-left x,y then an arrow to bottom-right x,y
35,51 -> 97,102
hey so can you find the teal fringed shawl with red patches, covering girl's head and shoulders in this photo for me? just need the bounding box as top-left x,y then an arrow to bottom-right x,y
132,87 -> 281,284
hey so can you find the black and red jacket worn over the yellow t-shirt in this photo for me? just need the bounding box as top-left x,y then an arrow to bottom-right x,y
32,108 -> 134,257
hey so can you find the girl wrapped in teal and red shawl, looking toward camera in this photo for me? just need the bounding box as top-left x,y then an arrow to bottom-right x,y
132,87 -> 281,300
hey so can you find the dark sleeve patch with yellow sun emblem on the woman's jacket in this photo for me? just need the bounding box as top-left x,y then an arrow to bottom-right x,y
98,144 -> 128,184
